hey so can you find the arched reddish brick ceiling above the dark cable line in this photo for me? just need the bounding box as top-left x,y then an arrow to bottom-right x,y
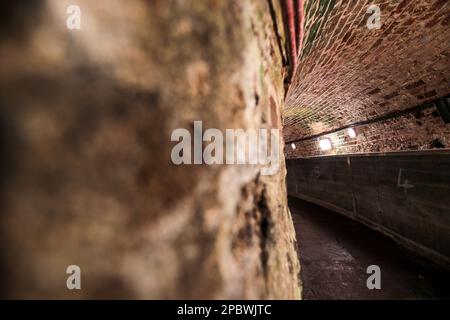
284,0 -> 450,142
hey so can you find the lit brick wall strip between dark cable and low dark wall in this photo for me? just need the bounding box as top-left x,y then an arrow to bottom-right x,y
285,107 -> 450,158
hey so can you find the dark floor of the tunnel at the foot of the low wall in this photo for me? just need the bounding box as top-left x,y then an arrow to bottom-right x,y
289,198 -> 450,300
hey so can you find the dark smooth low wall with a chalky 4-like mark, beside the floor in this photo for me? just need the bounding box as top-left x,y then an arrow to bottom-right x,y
287,151 -> 450,267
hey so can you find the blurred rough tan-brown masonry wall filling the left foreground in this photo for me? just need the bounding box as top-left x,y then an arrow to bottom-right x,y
0,0 -> 301,299
